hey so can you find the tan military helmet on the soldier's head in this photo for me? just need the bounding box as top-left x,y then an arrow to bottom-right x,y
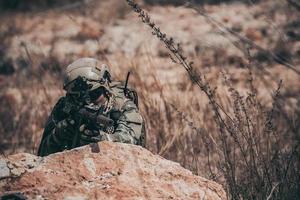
64,58 -> 111,94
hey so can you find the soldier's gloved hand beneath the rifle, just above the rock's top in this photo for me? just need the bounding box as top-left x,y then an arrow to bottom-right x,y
79,124 -> 102,145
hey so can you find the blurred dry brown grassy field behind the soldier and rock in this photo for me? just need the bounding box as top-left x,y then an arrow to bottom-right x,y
0,0 -> 300,199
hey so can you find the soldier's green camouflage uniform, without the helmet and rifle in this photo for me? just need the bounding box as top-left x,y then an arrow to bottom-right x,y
38,57 -> 146,156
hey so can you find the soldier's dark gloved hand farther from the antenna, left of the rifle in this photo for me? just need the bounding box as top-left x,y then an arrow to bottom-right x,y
53,118 -> 75,140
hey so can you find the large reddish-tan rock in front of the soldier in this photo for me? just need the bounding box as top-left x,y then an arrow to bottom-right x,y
0,142 -> 226,200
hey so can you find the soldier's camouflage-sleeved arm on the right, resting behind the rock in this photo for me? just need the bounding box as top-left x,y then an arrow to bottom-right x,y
105,99 -> 145,146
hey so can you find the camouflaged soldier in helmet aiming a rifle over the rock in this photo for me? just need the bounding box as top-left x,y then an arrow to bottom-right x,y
38,58 -> 146,156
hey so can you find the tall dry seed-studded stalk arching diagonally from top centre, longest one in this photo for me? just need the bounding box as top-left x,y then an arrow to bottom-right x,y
126,0 -> 241,197
